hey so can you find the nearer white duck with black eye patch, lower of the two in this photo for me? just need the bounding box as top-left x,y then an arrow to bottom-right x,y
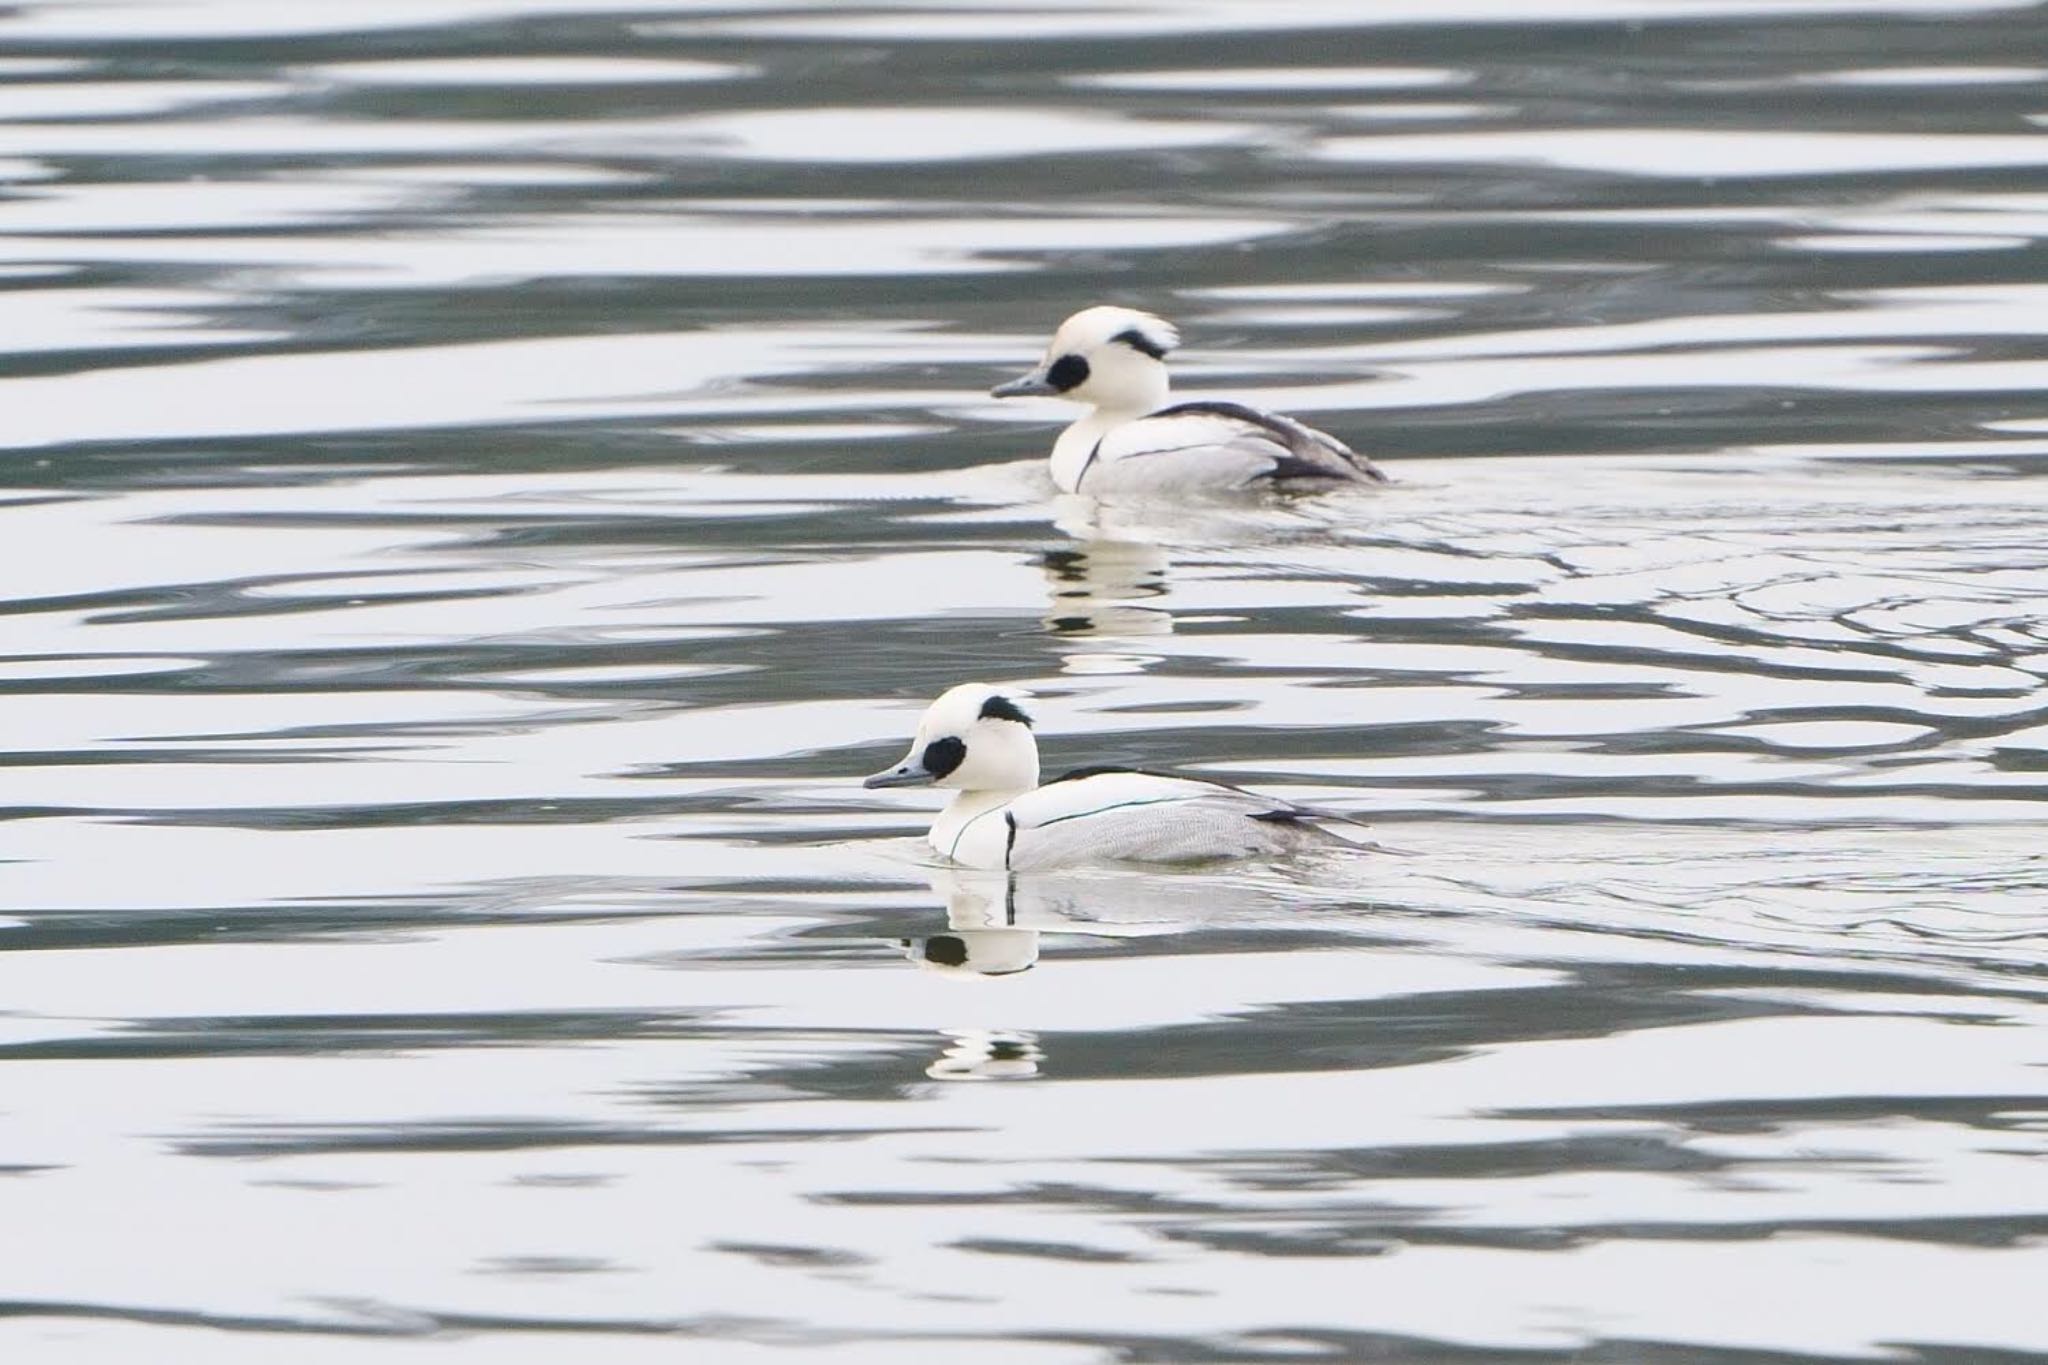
862,684 -> 1356,872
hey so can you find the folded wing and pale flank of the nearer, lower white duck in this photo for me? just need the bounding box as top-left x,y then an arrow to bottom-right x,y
1008,769 -> 1305,870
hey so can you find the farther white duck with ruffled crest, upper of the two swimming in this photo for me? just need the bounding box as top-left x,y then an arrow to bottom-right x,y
989,303 -> 1386,495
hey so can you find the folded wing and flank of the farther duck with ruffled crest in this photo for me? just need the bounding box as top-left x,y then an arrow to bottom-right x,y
1083,401 -> 1386,485
